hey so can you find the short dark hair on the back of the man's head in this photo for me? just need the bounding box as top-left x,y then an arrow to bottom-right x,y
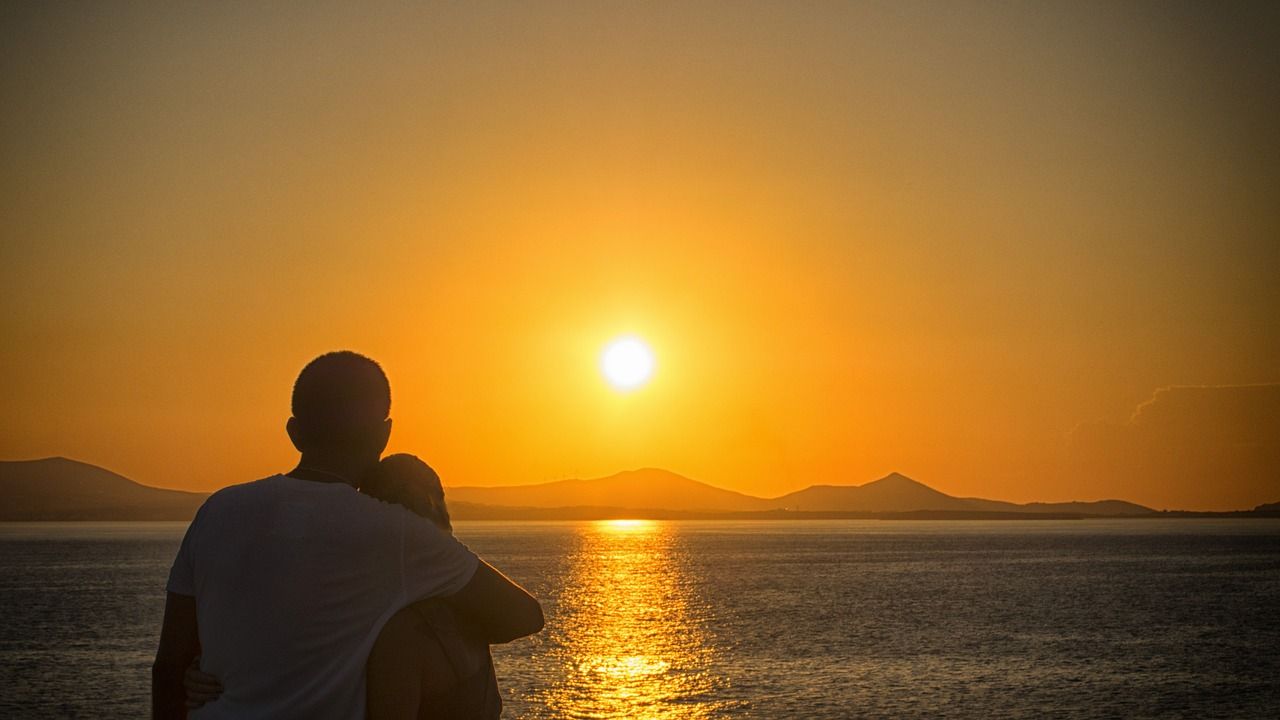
292,350 -> 392,445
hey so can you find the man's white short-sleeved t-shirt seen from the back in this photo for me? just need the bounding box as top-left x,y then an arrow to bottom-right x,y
168,475 -> 477,720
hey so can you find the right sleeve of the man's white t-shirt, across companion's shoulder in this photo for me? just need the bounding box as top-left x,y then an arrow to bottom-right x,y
401,510 -> 480,602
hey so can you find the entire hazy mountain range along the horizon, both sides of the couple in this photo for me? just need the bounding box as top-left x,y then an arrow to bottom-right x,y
0,457 -> 1177,520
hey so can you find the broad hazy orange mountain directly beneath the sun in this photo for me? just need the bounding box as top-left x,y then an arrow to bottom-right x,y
445,468 -> 776,512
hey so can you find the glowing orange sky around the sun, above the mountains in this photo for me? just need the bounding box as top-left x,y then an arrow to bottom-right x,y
0,3 -> 1280,509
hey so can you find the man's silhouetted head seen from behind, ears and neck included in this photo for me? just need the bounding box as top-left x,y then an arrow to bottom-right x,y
287,350 -> 392,464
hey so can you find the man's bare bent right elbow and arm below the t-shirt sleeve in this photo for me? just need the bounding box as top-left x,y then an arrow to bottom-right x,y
444,560 -> 544,643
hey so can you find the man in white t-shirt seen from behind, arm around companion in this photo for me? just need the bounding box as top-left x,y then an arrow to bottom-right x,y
151,352 -> 543,719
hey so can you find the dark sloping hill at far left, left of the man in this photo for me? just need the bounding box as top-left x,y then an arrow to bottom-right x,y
0,457 -> 207,520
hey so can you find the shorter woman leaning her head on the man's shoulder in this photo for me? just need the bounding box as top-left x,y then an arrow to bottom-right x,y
184,455 -> 502,720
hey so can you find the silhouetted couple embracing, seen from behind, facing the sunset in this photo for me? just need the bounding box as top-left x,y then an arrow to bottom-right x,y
151,352 -> 543,720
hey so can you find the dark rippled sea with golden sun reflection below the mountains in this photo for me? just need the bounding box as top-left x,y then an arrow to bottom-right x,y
0,519 -> 1280,720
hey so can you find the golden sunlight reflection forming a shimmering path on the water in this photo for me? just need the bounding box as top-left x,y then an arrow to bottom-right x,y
529,520 -> 723,719
